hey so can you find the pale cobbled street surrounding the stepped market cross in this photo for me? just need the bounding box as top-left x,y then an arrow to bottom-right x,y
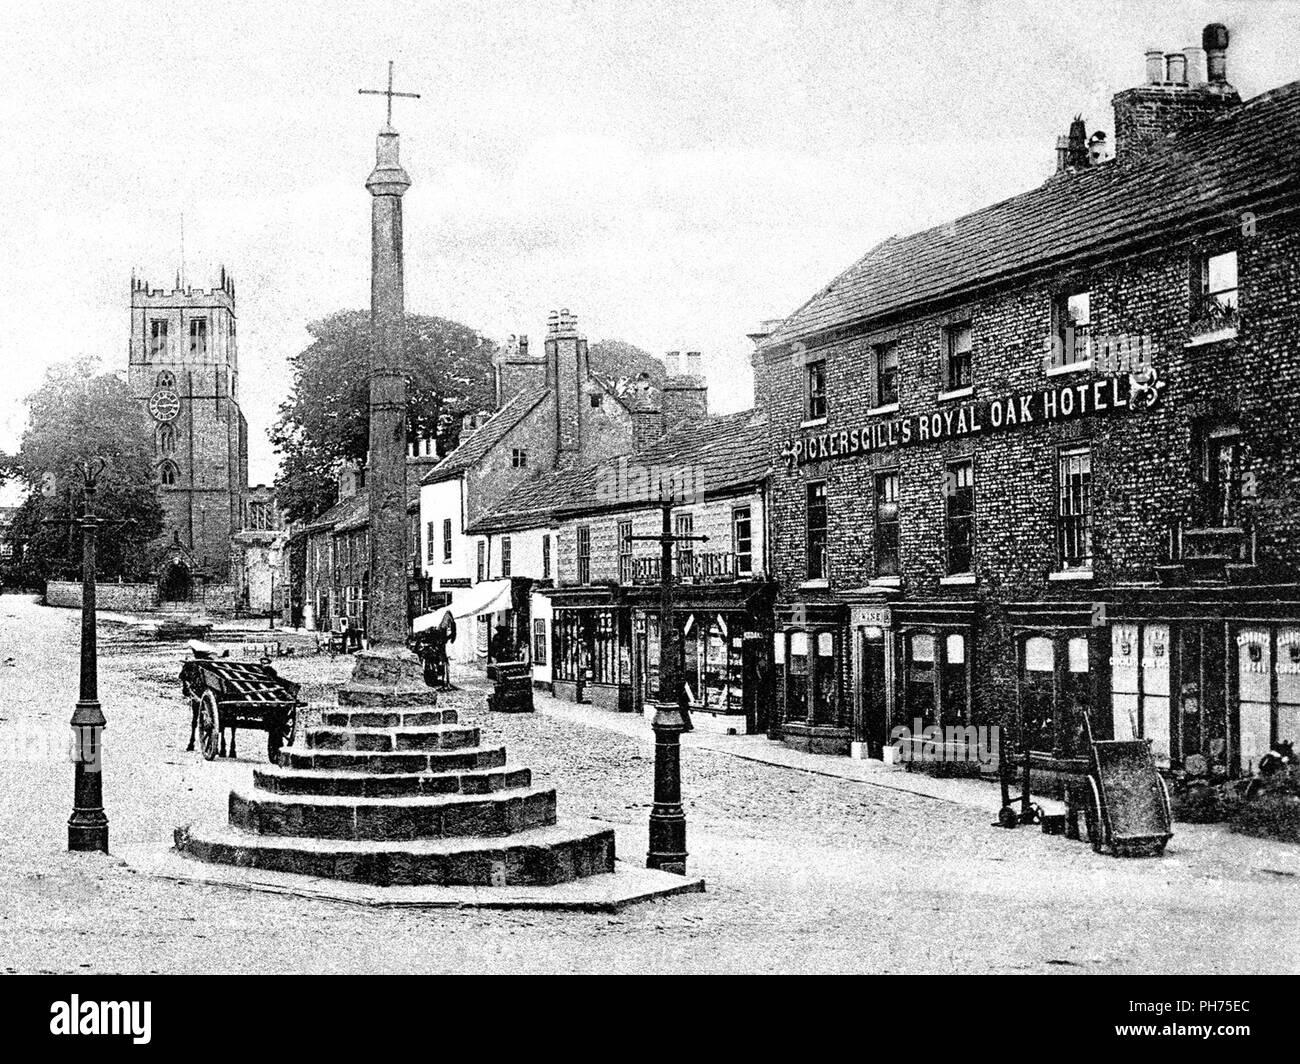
0,596 -> 1300,973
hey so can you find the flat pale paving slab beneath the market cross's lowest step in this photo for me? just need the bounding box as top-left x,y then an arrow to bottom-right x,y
113,845 -> 705,913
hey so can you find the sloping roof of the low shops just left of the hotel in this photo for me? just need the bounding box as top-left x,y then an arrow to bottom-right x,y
468,410 -> 770,535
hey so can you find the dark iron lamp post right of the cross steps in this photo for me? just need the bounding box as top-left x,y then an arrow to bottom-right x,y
632,499 -> 709,875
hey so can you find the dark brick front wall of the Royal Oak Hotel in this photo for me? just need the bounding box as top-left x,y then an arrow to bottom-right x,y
755,208 -> 1300,723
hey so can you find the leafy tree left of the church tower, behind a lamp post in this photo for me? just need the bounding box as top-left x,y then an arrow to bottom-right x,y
0,359 -> 163,581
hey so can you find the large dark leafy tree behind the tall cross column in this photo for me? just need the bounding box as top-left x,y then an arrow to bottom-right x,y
270,311 -> 495,520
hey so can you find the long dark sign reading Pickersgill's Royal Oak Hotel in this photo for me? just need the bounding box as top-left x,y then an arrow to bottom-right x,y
781,367 -> 1165,468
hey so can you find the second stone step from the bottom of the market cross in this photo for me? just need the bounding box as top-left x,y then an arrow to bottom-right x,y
230,787 -> 555,842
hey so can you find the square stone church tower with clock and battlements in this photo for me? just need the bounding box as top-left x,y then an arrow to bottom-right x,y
129,268 -> 248,580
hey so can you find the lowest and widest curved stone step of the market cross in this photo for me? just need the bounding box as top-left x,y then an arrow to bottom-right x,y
176,823 -> 614,887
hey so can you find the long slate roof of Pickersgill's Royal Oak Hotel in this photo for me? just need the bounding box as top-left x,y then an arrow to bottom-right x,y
764,82 -> 1300,347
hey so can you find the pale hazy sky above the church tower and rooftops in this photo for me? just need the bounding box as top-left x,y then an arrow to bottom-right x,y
0,0 -> 1300,502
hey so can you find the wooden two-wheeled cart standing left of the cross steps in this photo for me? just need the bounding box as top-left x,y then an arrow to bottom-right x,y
181,652 -> 304,762
